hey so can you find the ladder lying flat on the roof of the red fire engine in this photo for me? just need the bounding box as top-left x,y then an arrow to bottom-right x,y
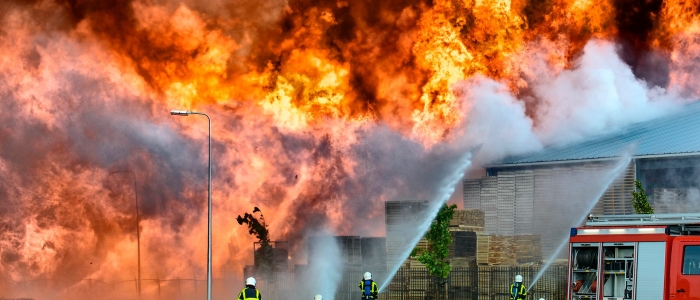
586,213 -> 700,234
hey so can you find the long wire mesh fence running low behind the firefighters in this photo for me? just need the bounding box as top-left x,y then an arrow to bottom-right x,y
0,265 -> 568,300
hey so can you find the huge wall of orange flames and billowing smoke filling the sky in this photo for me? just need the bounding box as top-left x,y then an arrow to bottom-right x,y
0,0 -> 700,292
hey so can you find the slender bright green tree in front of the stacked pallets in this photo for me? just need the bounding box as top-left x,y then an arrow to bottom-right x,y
411,204 -> 457,298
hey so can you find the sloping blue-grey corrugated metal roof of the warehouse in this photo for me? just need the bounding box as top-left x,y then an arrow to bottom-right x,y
489,101 -> 700,167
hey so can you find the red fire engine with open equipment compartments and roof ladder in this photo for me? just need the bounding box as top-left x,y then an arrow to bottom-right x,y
567,214 -> 700,300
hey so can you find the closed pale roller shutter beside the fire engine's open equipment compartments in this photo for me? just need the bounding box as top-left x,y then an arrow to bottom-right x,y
634,242 -> 666,300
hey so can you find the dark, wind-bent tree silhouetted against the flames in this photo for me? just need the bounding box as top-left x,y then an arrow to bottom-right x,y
236,207 -> 274,278
